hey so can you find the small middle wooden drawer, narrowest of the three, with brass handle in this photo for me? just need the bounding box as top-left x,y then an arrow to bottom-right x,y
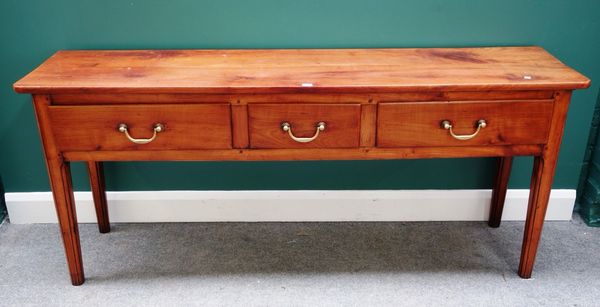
248,103 -> 360,148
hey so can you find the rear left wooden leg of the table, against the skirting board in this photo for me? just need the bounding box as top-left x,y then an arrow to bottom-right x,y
87,161 -> 110,233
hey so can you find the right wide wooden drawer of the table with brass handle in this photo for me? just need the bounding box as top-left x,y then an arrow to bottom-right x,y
377,100 -> 554,147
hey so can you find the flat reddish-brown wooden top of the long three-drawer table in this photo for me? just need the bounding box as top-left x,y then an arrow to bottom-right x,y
14,47 -> 590,94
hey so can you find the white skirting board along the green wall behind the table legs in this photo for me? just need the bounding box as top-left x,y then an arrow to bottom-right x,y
5,190 -> 575,224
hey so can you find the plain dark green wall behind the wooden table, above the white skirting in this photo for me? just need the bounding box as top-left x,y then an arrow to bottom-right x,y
0,0 -> 600,192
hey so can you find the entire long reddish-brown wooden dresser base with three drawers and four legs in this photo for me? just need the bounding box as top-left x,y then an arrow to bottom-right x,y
14,47 -> 590,285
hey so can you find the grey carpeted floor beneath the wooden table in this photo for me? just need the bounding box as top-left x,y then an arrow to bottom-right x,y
0,216 -> 600,306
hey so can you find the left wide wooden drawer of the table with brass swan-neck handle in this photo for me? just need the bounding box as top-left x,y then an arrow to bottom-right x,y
49,104 -> 231,151
